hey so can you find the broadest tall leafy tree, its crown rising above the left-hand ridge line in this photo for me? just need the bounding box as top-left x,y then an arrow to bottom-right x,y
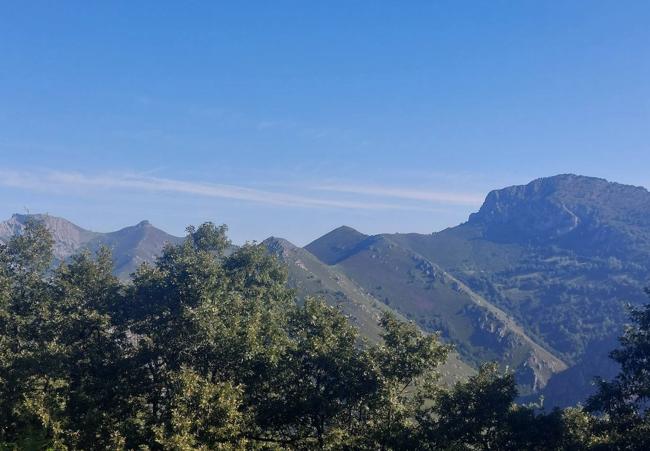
123,223 -> 293,448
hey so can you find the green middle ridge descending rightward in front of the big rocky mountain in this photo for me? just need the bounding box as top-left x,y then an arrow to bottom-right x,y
307,228 -> 566,391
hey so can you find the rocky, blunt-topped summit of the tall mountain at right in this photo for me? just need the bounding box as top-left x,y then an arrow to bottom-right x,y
468,174 -> 650,252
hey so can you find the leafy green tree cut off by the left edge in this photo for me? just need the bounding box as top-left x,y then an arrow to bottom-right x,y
0,220 -> 62,446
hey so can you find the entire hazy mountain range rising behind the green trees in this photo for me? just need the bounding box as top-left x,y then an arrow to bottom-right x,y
0,175 -> 650,405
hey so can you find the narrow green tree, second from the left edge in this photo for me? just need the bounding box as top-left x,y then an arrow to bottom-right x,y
41,248 -> 132,449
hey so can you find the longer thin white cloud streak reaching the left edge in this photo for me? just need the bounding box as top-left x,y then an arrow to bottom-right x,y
0,170 -> 456,211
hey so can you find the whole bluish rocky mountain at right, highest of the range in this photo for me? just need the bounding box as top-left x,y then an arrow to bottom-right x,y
384,175 -> 650,405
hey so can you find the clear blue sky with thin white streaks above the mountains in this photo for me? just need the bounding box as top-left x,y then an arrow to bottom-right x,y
0,0 -> 650,244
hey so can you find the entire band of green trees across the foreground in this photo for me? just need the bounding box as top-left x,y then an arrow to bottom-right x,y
0,222 -> 650,450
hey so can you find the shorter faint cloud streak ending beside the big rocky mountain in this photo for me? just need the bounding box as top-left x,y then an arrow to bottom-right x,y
312,184 -> 483,206
